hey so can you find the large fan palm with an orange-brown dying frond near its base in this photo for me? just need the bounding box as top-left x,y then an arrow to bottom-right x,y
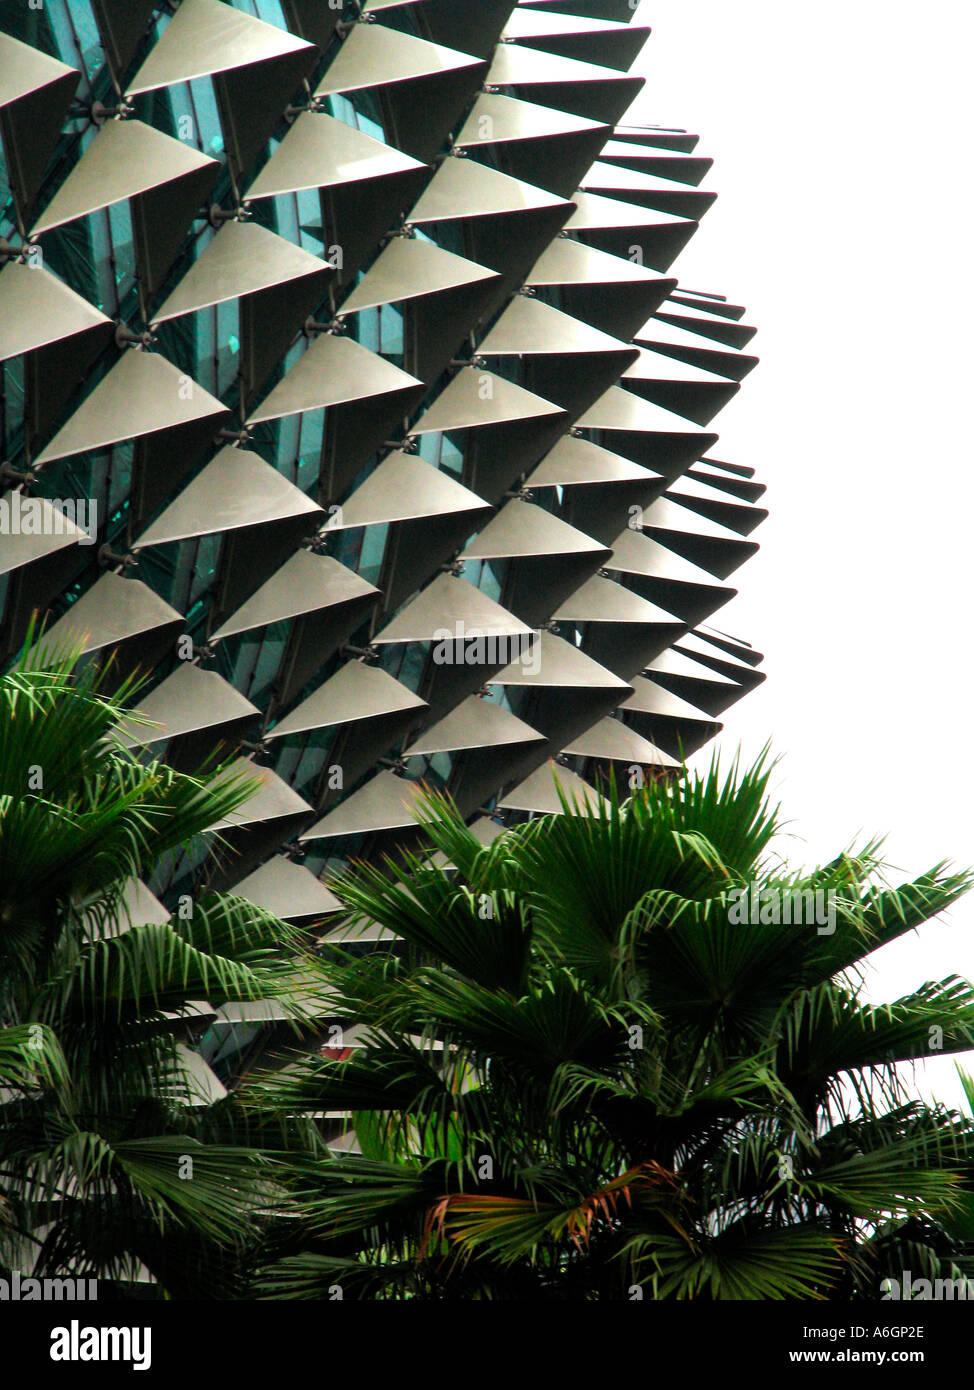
252,758 -> 974,1300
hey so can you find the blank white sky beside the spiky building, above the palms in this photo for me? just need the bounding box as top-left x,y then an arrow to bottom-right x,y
635,0 -> 974,1104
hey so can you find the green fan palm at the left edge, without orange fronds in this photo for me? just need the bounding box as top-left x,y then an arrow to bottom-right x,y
0,652 -> 326,1298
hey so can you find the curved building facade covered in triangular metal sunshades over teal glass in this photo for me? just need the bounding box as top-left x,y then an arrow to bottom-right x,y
0,0 -> 766,935
